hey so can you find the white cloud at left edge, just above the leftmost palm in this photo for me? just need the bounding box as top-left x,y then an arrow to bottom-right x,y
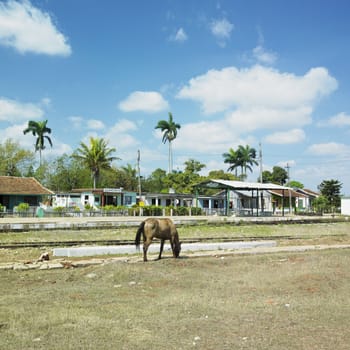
0,97 -> 44,123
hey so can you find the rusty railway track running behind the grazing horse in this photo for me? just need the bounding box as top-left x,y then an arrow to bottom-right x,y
0,235 -> 339,249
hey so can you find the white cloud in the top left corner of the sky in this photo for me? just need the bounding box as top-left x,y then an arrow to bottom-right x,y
0,0 -> 71,56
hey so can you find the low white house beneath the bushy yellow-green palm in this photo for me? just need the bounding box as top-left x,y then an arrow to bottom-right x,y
52,188 -> 136,209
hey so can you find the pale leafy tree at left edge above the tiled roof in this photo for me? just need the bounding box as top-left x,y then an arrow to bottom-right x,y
0,139 -> 34,176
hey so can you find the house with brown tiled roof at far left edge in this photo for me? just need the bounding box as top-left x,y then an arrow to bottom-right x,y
0,176 -> 54,210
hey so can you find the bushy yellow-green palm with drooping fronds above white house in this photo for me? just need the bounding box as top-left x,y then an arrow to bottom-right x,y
73,137 -> 120,189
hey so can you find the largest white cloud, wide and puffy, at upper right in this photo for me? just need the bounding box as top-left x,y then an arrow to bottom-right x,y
177,65 -> 338,114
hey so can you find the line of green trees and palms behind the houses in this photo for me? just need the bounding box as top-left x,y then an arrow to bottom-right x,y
0,113 -> 342,208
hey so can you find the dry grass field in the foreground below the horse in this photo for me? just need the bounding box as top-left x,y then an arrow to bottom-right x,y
0,250 -> 350,350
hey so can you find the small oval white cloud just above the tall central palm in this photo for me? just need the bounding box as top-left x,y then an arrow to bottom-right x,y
119,91 -> 169,113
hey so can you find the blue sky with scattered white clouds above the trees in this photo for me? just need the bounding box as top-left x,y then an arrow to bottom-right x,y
0,0 -> 350,195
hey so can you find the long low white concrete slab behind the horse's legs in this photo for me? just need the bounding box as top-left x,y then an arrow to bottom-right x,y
53,241 -> 276,257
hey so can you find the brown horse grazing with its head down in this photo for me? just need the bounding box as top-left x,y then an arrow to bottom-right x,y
135,218 -> 181,261
